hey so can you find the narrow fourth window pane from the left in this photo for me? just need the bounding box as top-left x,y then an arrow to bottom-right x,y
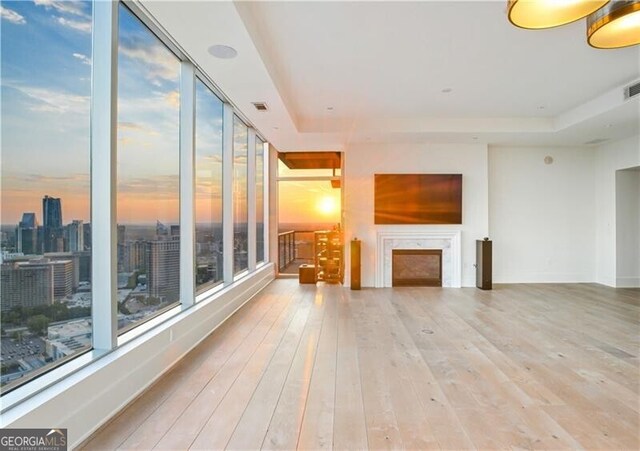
233,116 -> 249,274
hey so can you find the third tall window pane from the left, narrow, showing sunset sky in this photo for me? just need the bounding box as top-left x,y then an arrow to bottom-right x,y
195,80 -> 224,291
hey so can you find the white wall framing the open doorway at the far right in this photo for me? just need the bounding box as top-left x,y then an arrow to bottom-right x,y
595,135 -> 640,287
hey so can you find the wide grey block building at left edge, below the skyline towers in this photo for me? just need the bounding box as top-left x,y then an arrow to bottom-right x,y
0,262 -> 54,312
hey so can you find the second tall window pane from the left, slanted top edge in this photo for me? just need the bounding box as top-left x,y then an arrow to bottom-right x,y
117,4 -> 180,330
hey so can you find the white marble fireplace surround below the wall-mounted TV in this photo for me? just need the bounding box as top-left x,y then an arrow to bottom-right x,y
375,229 -> 462,288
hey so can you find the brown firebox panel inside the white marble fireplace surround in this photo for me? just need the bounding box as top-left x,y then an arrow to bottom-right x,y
391,249 -> 442,287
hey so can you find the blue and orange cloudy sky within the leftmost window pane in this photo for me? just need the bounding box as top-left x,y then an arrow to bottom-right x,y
1,0 -> 91,224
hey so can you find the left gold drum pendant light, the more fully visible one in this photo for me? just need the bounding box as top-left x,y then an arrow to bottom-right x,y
508,0 -> 609,29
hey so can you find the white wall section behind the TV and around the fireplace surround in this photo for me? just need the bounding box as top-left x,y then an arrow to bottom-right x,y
343,143 -> 489,287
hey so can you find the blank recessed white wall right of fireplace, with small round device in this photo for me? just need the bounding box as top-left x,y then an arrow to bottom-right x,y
489,147 -> 595,283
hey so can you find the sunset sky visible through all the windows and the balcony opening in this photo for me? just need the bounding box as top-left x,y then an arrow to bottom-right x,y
0,0 -> 340,230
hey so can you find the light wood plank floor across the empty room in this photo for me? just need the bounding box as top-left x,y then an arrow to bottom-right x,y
84,279 -> 640,450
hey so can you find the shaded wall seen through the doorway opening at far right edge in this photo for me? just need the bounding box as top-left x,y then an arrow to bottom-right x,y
616,168 -> 640,287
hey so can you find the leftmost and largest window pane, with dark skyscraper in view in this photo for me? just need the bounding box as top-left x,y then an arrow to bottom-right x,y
0,1 -> 93,394
